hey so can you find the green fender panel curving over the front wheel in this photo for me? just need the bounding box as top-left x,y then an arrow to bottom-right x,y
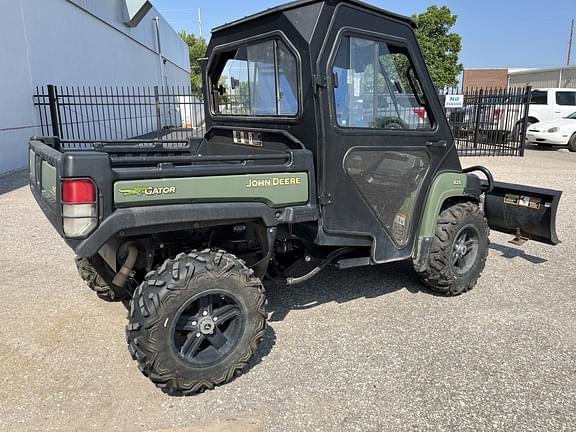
420,173 -> 467,238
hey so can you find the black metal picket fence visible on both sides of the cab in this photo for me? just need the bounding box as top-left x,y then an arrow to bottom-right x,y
34,85 -> 530,156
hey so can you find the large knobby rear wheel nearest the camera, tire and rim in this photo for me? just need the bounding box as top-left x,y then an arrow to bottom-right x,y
126,250 -> 267,395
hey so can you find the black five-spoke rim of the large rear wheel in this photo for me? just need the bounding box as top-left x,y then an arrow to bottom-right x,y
173,291 -> 244,367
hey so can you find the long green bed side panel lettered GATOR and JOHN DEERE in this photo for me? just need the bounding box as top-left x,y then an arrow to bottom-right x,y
114,172 -> 308,207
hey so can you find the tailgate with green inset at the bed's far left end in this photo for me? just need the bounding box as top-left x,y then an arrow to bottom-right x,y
29,139 -> 62,232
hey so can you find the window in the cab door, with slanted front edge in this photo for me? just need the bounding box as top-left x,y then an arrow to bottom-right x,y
332,37 -> 432,130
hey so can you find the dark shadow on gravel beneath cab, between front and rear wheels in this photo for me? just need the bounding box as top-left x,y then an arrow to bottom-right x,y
266,262 -> 424,322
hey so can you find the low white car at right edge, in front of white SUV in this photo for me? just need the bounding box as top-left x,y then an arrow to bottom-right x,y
526,112 -> 576,152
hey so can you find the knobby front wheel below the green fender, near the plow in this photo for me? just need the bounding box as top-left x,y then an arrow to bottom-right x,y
419,202 -> 490,296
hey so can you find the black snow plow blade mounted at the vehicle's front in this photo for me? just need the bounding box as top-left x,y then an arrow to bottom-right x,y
484,182 -> 562,245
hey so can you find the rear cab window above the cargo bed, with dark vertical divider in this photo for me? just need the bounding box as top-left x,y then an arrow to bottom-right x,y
211,40 -> 298,116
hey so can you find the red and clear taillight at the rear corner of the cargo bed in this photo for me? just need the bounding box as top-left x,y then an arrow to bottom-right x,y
62,179 -> 98,237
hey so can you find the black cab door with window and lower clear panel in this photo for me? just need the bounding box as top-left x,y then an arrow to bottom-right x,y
320,11 -> 460,263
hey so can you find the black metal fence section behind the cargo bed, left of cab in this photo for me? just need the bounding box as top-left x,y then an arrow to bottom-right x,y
34,85 -> 205,140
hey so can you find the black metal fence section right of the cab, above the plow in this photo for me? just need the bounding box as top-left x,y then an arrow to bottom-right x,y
440,87 -> 531,156
